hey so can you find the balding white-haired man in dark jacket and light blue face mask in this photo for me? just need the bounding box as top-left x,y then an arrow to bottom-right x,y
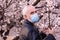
20,5 -> 55,40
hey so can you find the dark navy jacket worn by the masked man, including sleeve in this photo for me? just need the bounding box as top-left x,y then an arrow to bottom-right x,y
20,20 -> 55,40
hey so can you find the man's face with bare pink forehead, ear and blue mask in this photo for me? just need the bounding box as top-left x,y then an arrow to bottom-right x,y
23,6 -> 39,22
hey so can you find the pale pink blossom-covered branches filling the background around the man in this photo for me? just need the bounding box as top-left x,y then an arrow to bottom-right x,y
0,0 -> 60,40
